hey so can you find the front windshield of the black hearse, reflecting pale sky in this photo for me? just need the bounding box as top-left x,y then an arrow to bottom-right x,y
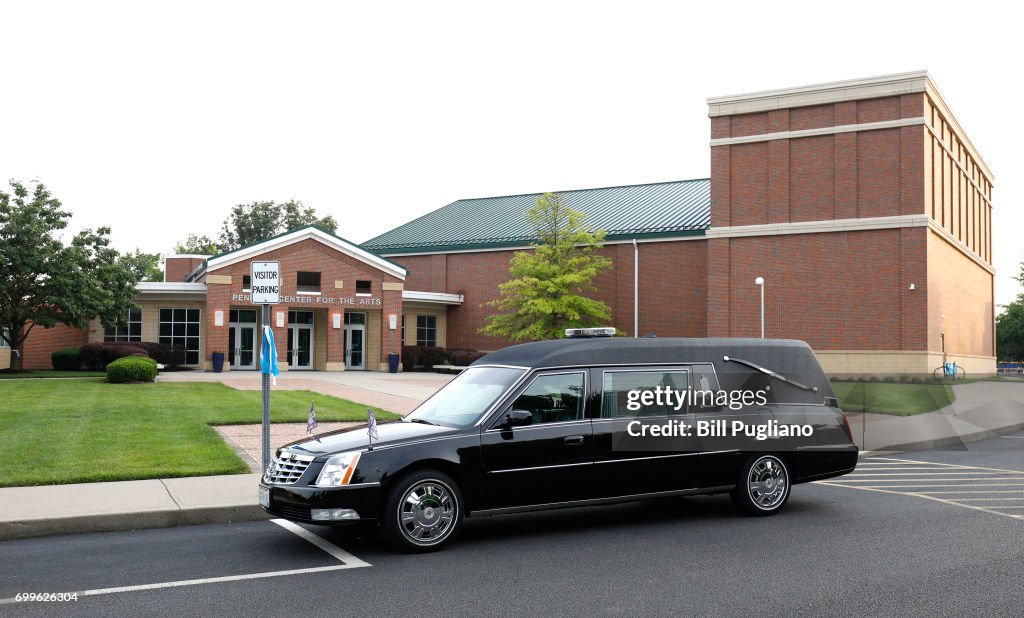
404,367 -> 524,427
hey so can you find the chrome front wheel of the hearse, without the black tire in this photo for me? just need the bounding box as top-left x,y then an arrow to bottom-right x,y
397,479 -> 459,546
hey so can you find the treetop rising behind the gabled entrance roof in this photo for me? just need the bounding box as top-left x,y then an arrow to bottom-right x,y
220,200 -> 338,251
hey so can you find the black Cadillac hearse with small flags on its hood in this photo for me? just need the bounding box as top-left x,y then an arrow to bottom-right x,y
260,329 -> 857,551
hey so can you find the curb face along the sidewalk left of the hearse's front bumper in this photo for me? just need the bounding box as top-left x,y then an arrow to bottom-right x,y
0,504 -> 270,541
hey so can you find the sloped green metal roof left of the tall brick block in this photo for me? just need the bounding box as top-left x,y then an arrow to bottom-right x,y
361,178 -> 711,254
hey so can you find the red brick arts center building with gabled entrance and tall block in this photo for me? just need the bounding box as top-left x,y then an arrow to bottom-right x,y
14,72 -> 995,373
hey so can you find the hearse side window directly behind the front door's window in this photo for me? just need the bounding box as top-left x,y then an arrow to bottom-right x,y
601,369 -> 689,418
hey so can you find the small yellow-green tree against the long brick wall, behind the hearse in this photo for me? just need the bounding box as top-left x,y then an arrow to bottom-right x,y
480,193 -> 611,341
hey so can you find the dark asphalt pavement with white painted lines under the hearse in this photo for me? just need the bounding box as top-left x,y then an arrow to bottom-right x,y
0,434 -> 1024,618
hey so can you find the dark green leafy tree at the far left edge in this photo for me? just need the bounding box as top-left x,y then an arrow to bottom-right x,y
0,180 -> 136,369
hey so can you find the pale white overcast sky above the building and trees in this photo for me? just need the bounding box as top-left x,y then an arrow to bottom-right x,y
0,0 -> 1024,303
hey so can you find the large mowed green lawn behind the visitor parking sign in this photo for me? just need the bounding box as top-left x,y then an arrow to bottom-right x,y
0,379 -> 397,487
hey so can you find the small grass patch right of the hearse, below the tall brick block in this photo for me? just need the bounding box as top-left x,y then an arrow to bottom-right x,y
833,382 -> 956,416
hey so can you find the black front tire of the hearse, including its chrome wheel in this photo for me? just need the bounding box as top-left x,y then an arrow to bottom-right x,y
382,470 -> 463,553
